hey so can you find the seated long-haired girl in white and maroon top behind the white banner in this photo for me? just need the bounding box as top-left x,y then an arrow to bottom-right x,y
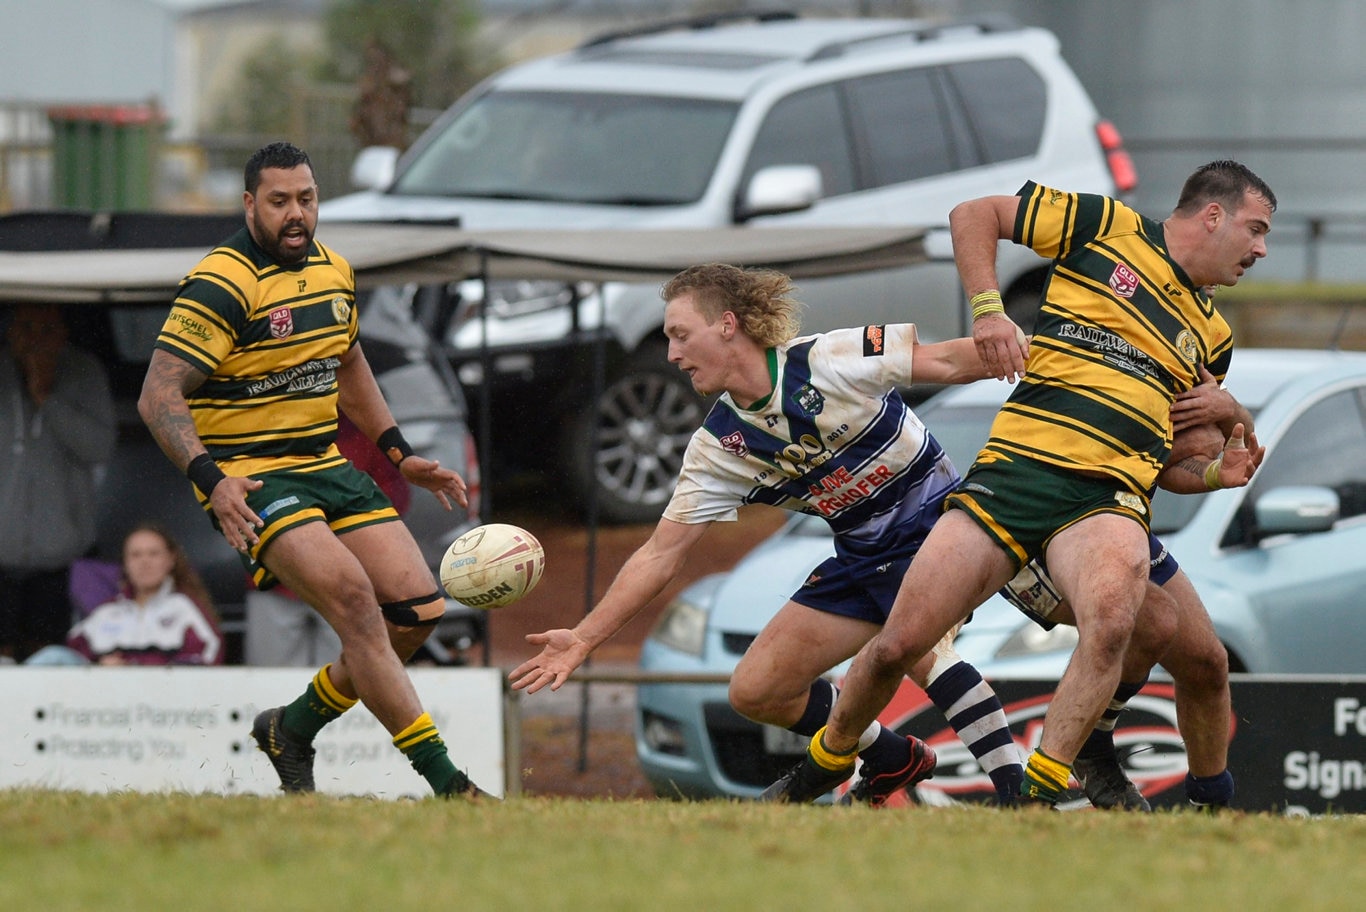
53,523 -> 223,665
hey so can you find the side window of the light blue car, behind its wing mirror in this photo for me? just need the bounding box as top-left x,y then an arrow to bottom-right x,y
1224,386 -> 1366,546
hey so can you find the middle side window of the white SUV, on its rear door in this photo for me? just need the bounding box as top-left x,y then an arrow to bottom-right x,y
848,68 -> 963,187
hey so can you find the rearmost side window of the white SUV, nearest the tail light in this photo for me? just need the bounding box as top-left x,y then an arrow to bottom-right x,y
945,57 -> 1048,162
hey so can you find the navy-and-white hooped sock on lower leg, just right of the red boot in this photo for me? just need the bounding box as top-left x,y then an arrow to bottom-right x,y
925,659 -> 1025,800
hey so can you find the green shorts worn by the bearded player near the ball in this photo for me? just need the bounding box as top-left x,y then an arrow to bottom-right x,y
208,461 -> 399,590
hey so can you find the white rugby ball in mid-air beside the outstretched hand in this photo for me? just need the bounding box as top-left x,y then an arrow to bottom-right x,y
441,523 -> 545,608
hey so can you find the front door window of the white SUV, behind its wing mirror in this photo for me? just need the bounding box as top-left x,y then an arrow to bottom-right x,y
740,86 -> 854,197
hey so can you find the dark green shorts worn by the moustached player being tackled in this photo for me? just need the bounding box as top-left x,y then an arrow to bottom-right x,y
945,456 -> 1149,572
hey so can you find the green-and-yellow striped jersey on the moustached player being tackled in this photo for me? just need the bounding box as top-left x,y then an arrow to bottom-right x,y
979,182 -> 1232,496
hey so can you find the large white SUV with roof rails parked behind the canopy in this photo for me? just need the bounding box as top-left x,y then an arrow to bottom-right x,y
321,14 -> 1135,522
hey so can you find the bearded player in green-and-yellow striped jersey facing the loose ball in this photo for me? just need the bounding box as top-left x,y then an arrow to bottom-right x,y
138,142 -> 481,795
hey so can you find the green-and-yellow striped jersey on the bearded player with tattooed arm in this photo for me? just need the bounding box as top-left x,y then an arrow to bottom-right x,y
156,228 -> 358,475
